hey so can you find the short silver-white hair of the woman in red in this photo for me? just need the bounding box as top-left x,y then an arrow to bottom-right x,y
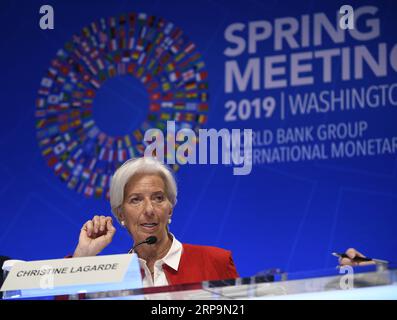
110,157 -> 178,222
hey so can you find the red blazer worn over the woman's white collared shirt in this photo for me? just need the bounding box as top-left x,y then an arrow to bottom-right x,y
163,243 -> 239,285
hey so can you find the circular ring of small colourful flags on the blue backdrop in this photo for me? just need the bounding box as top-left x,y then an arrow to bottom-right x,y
36,13 -> 208,198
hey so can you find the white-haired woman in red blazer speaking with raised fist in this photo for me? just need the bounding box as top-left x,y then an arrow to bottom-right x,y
73,157 -> 238,287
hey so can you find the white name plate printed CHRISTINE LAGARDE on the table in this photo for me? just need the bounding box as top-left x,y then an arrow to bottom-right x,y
1,254 -> 142,298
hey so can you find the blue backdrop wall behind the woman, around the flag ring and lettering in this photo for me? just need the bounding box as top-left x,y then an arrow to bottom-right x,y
0,0 -> 397,276
